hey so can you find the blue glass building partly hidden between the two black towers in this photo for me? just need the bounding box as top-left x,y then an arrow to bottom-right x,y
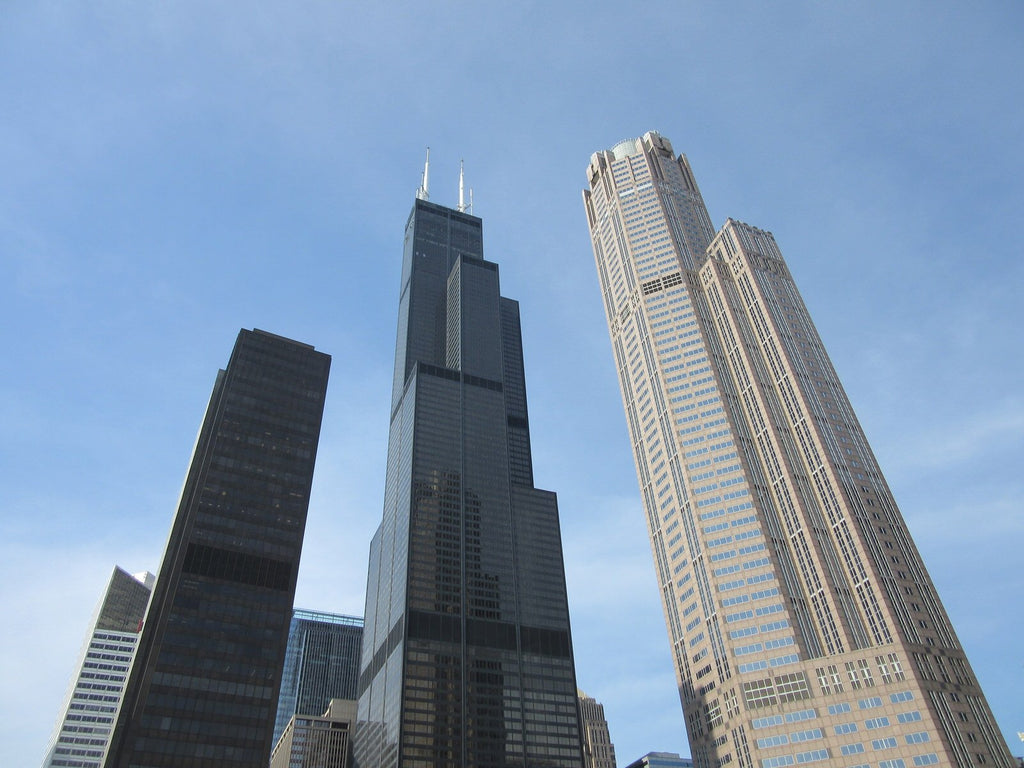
273,610 -> 362,744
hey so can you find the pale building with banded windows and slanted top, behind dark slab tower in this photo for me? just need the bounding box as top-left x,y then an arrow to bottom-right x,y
43,567 -> 153,768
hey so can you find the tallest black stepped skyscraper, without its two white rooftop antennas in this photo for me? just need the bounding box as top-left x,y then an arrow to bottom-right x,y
355,193 -> 583,768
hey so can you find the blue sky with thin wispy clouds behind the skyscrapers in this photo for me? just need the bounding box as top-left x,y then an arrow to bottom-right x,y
0,0 -> 1024,766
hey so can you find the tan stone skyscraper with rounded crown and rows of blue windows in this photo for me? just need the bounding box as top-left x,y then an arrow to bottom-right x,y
584,133 -> 1010,768
